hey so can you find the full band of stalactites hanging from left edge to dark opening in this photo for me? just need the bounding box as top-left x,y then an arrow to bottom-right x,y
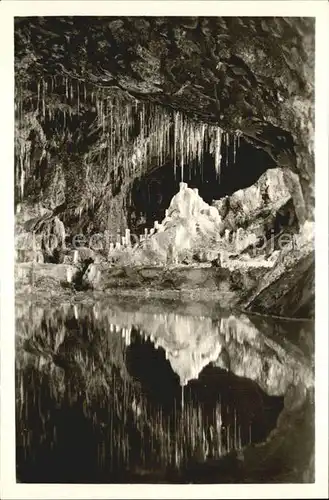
15,72 -> 239,208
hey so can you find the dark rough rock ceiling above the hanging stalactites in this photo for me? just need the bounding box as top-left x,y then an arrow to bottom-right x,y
15,17 -> 314,154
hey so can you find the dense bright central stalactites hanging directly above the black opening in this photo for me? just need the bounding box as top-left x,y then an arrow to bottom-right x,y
87,98 -> 239,191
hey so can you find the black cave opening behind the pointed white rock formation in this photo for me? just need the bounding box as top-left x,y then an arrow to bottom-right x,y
129,138 -> 277,230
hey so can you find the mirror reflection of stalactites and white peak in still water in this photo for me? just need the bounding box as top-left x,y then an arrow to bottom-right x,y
16,304 -> 307,482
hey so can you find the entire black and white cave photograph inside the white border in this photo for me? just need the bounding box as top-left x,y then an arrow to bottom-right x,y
1,2 -> 328,498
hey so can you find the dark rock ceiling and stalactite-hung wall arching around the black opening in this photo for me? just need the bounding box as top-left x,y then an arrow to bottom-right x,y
15,17 -> 314,234
